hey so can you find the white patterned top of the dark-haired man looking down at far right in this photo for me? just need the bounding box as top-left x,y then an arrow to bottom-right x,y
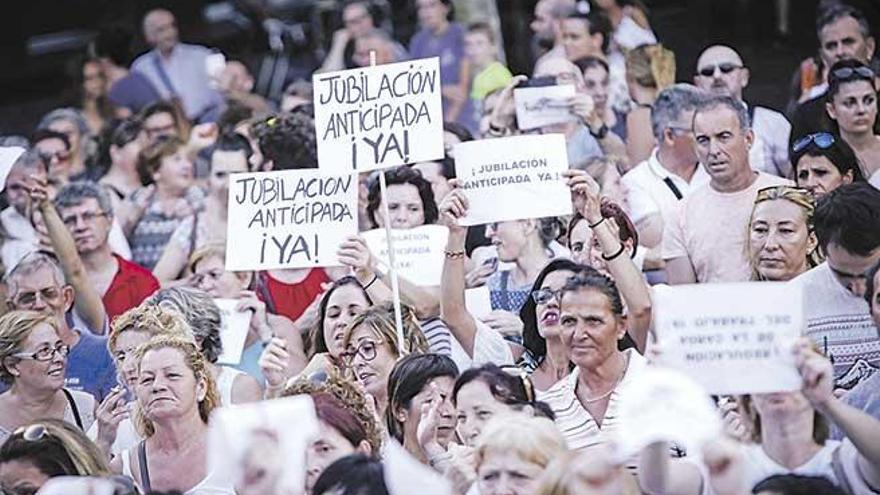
791,262 -> 880,389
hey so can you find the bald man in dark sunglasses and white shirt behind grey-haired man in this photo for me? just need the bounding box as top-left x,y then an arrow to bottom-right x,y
694,45 -> 791,177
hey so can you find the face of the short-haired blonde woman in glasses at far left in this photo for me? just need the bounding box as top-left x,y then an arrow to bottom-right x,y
15,323 -> 67,390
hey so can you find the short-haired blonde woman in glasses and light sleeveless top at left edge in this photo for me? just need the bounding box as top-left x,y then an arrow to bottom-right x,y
0,311 -> 95,442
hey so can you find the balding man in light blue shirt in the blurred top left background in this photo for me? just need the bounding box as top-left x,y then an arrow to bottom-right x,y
131,9 -> 224,123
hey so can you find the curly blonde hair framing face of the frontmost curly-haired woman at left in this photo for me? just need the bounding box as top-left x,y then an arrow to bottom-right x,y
134,335 -> 220,438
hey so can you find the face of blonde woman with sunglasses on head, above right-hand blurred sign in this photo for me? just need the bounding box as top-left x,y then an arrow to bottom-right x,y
749,199 -> 813,281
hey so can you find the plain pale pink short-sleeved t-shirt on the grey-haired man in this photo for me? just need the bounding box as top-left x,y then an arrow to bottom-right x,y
662,172 -> 792,283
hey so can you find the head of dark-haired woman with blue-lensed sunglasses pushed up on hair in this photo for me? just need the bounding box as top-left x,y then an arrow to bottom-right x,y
790,132 -> 865,200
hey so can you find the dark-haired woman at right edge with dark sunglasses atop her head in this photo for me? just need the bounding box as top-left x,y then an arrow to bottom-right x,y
825,60 -> 880,186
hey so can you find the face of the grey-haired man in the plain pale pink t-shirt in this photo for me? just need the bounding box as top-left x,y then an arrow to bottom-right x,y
694,106 -> 753,183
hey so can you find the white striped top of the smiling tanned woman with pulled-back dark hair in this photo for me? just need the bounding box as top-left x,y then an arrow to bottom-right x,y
538,349 -> 647,450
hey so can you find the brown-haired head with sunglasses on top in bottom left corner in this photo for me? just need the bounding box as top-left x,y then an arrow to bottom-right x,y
0,419 -> 110,495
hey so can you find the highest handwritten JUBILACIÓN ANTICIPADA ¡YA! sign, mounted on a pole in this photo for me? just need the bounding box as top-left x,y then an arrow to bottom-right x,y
312,57 -> 444,173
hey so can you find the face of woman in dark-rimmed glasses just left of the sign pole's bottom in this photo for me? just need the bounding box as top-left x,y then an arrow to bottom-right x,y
346,325 -> 397,397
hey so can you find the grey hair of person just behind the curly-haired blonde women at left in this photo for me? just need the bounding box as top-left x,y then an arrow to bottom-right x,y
144,287 -> 223,363
